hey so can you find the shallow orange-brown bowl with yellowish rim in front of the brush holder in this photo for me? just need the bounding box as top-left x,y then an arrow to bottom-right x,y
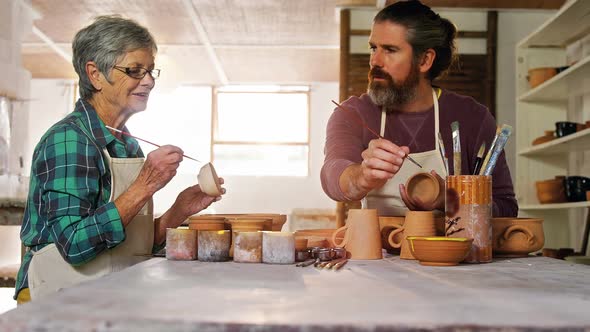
407,236 -> 473,266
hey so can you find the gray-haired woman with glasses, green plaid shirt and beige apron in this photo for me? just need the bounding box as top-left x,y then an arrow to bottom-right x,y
15,16 -> 225,303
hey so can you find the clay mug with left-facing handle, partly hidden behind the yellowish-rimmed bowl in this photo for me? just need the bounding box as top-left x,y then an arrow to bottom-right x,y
387,211 -> 436,259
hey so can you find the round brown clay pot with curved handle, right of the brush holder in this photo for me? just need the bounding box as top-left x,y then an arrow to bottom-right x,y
491,218 -> 545,257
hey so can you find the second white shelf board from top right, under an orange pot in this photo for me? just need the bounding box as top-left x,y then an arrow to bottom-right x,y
519,54 -> 590,102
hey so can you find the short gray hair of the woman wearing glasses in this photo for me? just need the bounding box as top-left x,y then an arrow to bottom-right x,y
72,15 -> 158,100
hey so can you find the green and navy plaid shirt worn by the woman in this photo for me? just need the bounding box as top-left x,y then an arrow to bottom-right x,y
15,99 -> 150,299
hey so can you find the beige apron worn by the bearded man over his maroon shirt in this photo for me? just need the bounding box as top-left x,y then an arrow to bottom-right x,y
362,89 -> 447,216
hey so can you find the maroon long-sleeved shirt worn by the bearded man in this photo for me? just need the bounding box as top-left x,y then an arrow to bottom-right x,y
321,90 -> 518,217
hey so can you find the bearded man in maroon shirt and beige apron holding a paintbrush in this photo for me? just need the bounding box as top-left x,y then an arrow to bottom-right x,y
321,1 -> 518,217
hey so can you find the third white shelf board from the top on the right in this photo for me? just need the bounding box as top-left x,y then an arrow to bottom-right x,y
518,128 -> 590,157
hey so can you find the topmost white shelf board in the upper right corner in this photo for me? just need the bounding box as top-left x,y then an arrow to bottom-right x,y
518,0 -> 590,47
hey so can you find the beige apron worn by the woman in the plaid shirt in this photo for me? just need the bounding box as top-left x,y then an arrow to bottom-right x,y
28,149 -> 154,300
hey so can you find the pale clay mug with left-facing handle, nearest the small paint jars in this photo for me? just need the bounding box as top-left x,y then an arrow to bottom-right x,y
332,209 -> 383,259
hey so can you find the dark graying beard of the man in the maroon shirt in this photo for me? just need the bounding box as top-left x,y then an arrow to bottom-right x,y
367,60 -> 420,112
